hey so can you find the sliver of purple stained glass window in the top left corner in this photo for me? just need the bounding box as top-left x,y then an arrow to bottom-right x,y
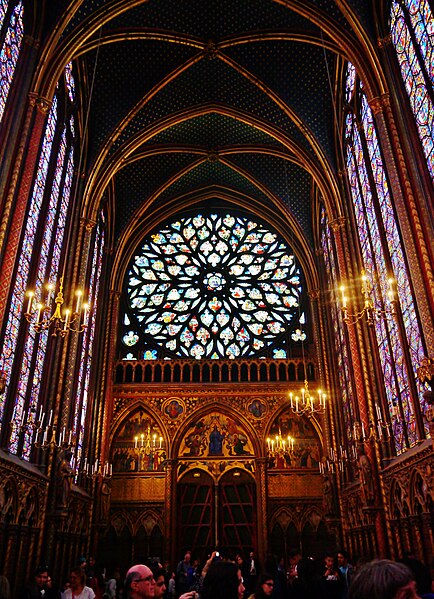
0,0 -> 24,123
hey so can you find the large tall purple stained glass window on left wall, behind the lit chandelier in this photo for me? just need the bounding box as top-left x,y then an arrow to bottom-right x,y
0,65 -> 74,459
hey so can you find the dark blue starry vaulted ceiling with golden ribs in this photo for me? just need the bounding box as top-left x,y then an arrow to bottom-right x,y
50,0 -> 384,249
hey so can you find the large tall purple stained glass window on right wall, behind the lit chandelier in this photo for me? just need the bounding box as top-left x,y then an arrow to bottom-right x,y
346,63 -> 426,453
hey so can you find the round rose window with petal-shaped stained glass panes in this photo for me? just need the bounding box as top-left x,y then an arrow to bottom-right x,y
123,214 -> 302,359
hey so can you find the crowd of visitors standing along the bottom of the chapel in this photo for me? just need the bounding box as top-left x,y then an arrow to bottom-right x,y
0,550 -> 434,599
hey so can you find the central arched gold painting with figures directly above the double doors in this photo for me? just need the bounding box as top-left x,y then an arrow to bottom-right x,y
179,412 -> 254,458
